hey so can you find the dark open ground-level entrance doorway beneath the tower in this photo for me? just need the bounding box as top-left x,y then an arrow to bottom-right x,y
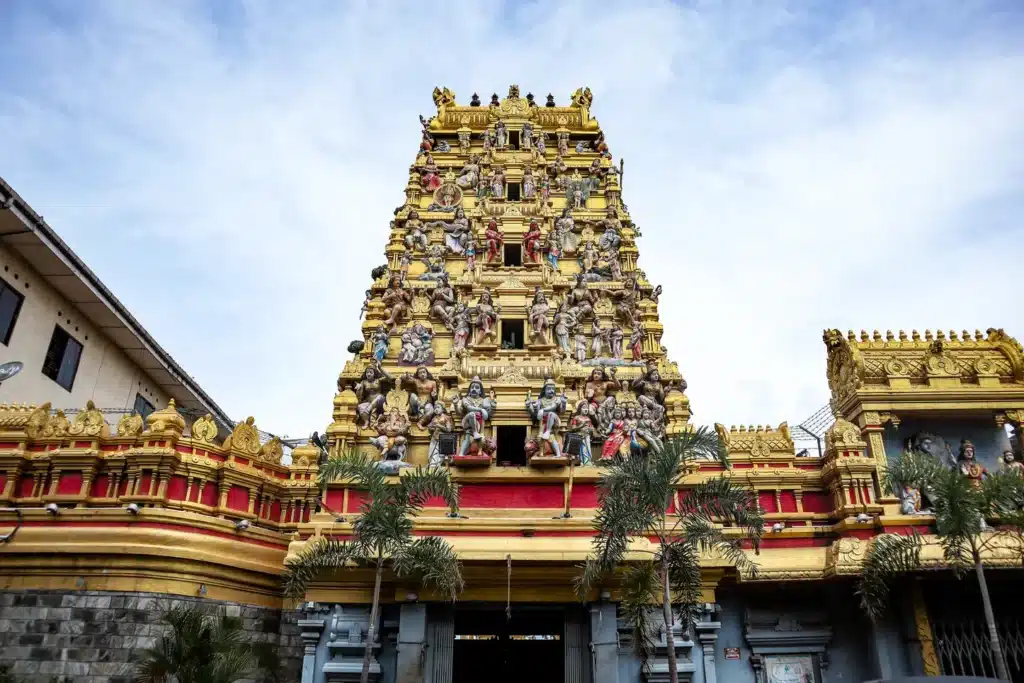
452,606 -> 565,683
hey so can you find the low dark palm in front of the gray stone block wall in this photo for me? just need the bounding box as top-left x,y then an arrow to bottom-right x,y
136,603 -> 281,683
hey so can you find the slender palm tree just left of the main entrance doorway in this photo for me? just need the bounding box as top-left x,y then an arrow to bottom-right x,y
284,452 -> 463,683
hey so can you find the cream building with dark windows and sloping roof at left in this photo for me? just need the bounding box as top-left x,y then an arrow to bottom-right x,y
0,178 -> 231,426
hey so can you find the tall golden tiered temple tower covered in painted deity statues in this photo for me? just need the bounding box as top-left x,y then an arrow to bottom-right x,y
328,86 -> 689,473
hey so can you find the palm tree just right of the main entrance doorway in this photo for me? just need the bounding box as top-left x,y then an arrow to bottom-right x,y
577,427 -> 764,683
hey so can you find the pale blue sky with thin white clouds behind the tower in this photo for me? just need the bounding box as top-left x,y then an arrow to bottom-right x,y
0,0 -> 1024,436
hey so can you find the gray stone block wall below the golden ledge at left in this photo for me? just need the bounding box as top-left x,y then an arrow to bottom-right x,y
0,591 -> 302,683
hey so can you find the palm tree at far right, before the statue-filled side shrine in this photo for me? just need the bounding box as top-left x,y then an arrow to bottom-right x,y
857,452 -> 1024,680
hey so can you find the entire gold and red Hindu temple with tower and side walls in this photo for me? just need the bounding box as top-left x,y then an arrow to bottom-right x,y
0,85 -> 1024,683
